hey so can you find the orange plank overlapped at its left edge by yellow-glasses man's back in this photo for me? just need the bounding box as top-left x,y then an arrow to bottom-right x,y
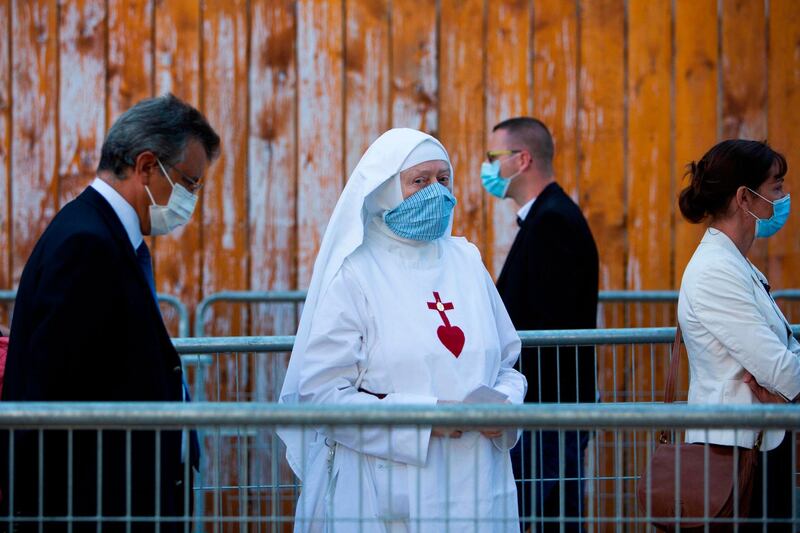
576,0 -> 629,516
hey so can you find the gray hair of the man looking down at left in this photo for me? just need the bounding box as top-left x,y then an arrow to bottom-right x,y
97,94 -> 219,179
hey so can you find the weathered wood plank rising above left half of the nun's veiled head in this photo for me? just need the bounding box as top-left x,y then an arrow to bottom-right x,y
344,0 -> 391,172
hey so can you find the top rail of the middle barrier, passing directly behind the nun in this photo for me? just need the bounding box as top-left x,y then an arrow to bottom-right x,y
172,324 -> 800,354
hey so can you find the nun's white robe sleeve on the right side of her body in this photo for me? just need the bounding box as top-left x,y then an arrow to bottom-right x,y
485,272 -> 528,452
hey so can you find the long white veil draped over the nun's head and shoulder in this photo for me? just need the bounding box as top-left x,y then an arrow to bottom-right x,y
278,128 -> 452,480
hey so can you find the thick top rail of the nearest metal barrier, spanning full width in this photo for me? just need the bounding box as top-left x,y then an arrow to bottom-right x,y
0,402 -> 800,429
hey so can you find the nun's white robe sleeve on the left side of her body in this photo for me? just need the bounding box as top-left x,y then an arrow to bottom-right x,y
298,263 -> 437,466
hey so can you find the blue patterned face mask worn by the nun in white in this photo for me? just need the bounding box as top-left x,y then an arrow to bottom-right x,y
383,183 -> 456,241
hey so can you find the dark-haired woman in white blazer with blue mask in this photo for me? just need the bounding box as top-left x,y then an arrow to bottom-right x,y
678,140 -> 800,531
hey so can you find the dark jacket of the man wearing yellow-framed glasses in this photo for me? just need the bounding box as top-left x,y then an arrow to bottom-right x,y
497,183 -> 598,402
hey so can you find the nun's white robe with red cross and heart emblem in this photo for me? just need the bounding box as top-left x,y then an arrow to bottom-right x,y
295,224 -> 527,533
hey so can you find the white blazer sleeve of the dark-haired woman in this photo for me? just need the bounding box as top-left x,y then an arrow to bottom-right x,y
689,261 -> 800,398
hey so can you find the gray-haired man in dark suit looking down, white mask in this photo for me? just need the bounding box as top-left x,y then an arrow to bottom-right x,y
0,95 -> 219,531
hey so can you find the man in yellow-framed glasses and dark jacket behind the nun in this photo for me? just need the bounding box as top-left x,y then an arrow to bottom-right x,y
481,117 -> 598,531
